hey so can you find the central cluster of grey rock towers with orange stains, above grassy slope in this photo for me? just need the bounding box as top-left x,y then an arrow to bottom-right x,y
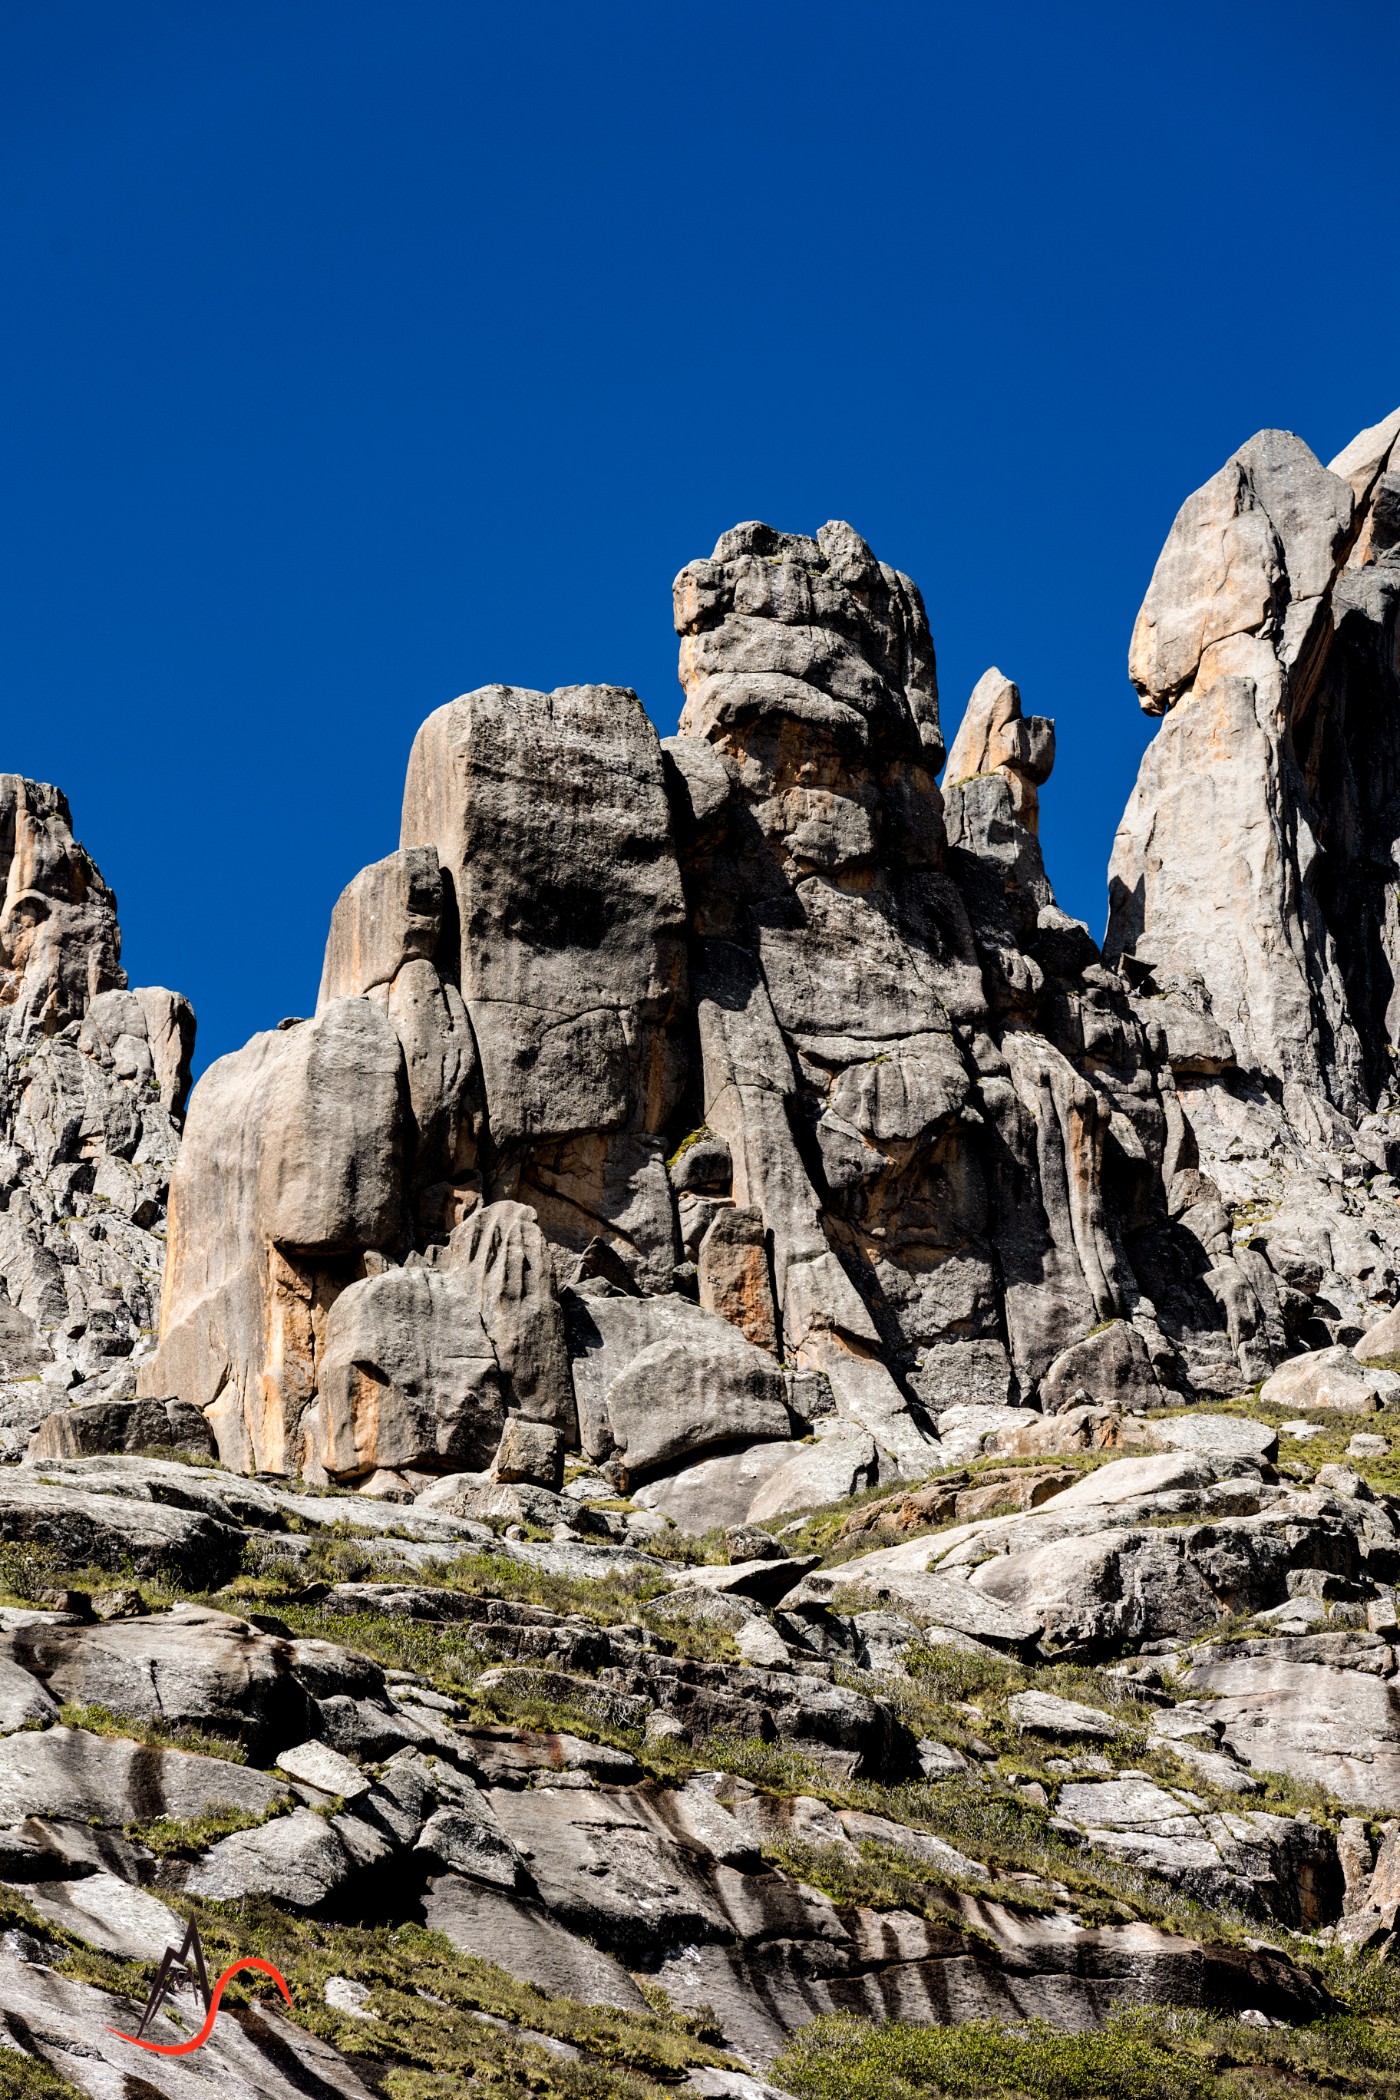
143,508 -> 1282,1486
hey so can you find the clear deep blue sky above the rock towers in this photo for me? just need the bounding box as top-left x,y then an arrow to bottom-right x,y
0,0 -> 1400,1063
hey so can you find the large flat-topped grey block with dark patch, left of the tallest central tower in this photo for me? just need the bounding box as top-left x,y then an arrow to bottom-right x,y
403,685 -> 684,1167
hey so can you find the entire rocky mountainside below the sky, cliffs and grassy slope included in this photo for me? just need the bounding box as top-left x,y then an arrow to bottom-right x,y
0,412 -> 1400,2100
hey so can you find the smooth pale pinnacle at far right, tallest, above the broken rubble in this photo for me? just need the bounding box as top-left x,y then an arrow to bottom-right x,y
1106,394 -> 1400,1119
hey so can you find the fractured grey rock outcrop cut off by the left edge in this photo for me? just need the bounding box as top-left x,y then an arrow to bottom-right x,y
0,773 -> 195,1460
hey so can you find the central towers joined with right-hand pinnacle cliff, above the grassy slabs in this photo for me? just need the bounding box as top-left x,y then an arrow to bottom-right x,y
114,401 -> 1400,1520
